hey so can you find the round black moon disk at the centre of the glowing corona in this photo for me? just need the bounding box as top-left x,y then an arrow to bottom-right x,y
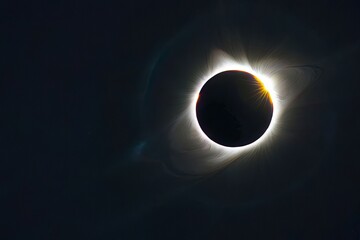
196,71 -> 273,147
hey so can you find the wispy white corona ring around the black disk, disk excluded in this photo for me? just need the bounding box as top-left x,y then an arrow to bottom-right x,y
169,51 -> 309,174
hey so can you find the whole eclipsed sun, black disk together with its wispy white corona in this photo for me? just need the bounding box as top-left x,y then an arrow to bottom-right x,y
151,50 -> 318,175
